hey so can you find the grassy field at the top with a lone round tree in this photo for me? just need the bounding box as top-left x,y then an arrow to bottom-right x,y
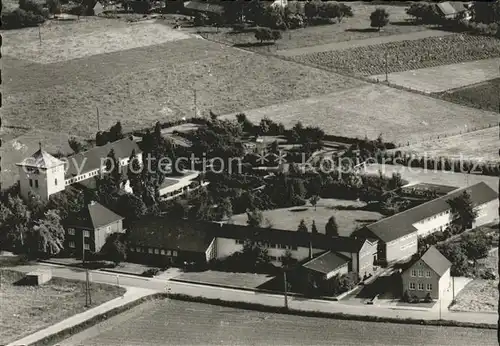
200,1 -> 427,52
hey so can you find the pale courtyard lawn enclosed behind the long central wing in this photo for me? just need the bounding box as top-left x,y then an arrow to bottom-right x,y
232,199 -> 383,236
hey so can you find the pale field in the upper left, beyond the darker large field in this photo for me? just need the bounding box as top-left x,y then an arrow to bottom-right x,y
2,19 -> 192,64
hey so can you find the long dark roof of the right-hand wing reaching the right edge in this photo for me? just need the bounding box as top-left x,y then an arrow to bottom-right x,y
366,182 -> 498,243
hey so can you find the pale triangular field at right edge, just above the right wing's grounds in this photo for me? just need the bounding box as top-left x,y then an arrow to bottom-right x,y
395,126 -> 500,162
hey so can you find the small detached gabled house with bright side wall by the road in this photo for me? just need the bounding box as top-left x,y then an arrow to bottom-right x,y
401,246 -> 451,299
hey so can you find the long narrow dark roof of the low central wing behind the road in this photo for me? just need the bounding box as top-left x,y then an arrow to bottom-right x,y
214,223 -> 365,253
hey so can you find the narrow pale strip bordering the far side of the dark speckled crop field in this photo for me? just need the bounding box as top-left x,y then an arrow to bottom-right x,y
276,30 -> 453,56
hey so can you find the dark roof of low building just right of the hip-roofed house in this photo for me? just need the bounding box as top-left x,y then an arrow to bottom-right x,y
128,217 -> 214,252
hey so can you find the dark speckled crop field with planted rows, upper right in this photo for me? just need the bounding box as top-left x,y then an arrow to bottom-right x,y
291,34 -> 500,76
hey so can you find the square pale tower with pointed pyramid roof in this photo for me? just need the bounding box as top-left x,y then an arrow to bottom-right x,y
17,143 -> 65,201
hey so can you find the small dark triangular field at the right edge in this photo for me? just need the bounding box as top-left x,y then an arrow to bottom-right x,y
438,77 -> 500,112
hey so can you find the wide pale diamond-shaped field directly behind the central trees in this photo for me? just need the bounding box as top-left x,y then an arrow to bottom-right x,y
227,84 -> 500,144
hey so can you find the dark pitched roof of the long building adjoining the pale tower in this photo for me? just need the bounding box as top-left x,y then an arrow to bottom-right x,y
66,137 -> 141,178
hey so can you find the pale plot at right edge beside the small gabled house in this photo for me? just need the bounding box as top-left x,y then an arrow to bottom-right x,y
450,248 -> 498,312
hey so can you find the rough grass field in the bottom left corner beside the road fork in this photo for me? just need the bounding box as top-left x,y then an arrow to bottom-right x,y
0,270 -> 125,344
